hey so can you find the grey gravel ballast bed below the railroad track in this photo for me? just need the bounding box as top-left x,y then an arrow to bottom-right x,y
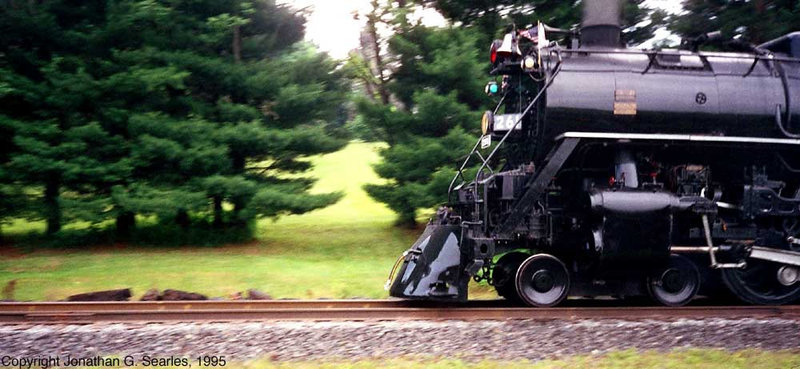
0,319 -> 800,361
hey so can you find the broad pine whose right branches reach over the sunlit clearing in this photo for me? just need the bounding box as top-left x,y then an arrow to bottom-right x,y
101,1 -> 345,226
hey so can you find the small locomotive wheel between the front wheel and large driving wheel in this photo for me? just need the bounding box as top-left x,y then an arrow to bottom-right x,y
647,255 -> 700,306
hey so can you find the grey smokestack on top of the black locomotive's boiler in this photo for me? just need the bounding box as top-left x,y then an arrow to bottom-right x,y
581,0 -> 622,47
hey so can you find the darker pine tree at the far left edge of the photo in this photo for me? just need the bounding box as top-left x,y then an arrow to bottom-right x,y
0,1 -> 128,233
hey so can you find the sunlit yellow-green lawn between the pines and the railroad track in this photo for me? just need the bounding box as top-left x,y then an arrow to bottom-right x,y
0,143 -> 466,300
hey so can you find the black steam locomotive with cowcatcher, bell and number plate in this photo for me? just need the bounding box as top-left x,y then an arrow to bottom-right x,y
387,0 -> 800,306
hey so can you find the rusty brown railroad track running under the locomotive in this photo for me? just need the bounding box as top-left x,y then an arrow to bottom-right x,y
0,300 -> 800,324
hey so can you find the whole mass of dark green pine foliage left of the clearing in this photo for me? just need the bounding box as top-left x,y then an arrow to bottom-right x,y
0,0 -> 347,234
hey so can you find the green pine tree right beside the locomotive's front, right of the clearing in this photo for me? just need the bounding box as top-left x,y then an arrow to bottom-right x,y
356,5 -> 486,224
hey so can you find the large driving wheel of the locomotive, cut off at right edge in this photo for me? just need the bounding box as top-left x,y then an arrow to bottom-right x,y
722,259 -> 800,305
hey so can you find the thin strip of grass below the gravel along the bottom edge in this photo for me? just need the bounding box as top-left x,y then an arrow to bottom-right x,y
191,349 -> 800,369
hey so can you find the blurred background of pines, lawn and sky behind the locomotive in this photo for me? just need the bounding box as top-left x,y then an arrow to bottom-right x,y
0,0 -> 800,300
